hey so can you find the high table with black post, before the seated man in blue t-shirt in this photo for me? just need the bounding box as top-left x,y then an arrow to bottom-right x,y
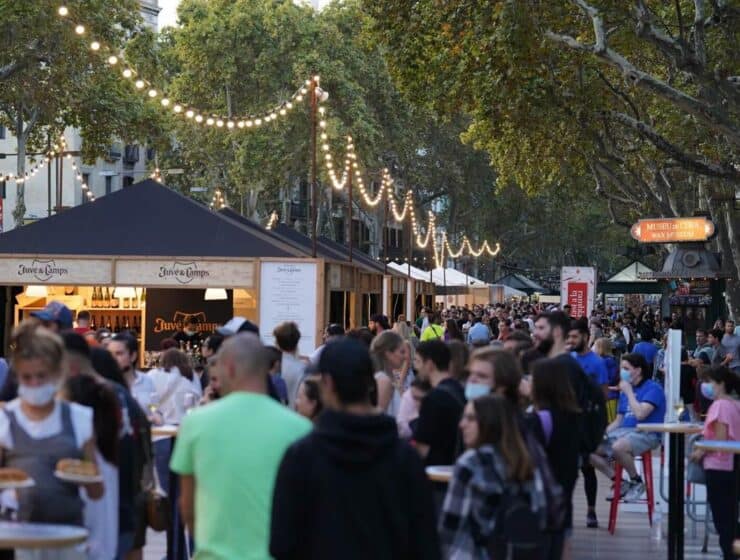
637,422 -> 703,560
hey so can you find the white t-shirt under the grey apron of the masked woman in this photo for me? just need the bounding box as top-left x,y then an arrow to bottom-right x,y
0,399 -> 93,449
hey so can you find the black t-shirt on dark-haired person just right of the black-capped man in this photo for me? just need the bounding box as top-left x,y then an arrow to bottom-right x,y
414,378 -> 465,465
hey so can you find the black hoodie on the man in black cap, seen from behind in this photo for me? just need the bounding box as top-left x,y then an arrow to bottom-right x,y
270,410 -> 440,560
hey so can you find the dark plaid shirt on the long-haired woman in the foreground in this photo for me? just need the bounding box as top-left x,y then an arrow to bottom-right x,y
439,445 -> 539,560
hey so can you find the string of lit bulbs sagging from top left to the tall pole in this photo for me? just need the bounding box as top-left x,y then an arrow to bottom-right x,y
57,5 -> 311,130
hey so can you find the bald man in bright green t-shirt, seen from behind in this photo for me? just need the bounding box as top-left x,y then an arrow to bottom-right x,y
170,334 -> 311,560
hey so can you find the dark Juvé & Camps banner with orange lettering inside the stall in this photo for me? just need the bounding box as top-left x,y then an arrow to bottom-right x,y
145,288 -> 234,351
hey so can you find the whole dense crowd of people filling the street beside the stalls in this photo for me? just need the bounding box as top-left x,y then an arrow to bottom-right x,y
0,303 -> 740,560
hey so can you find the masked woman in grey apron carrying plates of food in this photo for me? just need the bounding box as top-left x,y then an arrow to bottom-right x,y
0,321 -> 104,560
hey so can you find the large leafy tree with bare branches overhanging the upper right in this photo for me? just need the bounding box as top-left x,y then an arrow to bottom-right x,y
364,0 -> 740,314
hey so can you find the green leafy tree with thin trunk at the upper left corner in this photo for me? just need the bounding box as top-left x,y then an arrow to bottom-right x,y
0,0 -> 159,225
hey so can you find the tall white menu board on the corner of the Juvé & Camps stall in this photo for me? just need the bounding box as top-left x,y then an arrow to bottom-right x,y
259,261 -> 318,356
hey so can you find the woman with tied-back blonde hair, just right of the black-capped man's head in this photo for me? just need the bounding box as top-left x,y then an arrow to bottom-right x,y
370,331 -> 408,418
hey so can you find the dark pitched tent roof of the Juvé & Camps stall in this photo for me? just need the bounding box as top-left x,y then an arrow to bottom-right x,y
0,179 -> 303,258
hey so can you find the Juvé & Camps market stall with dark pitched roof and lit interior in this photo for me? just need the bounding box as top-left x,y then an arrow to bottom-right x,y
0,180 -> 324,355
